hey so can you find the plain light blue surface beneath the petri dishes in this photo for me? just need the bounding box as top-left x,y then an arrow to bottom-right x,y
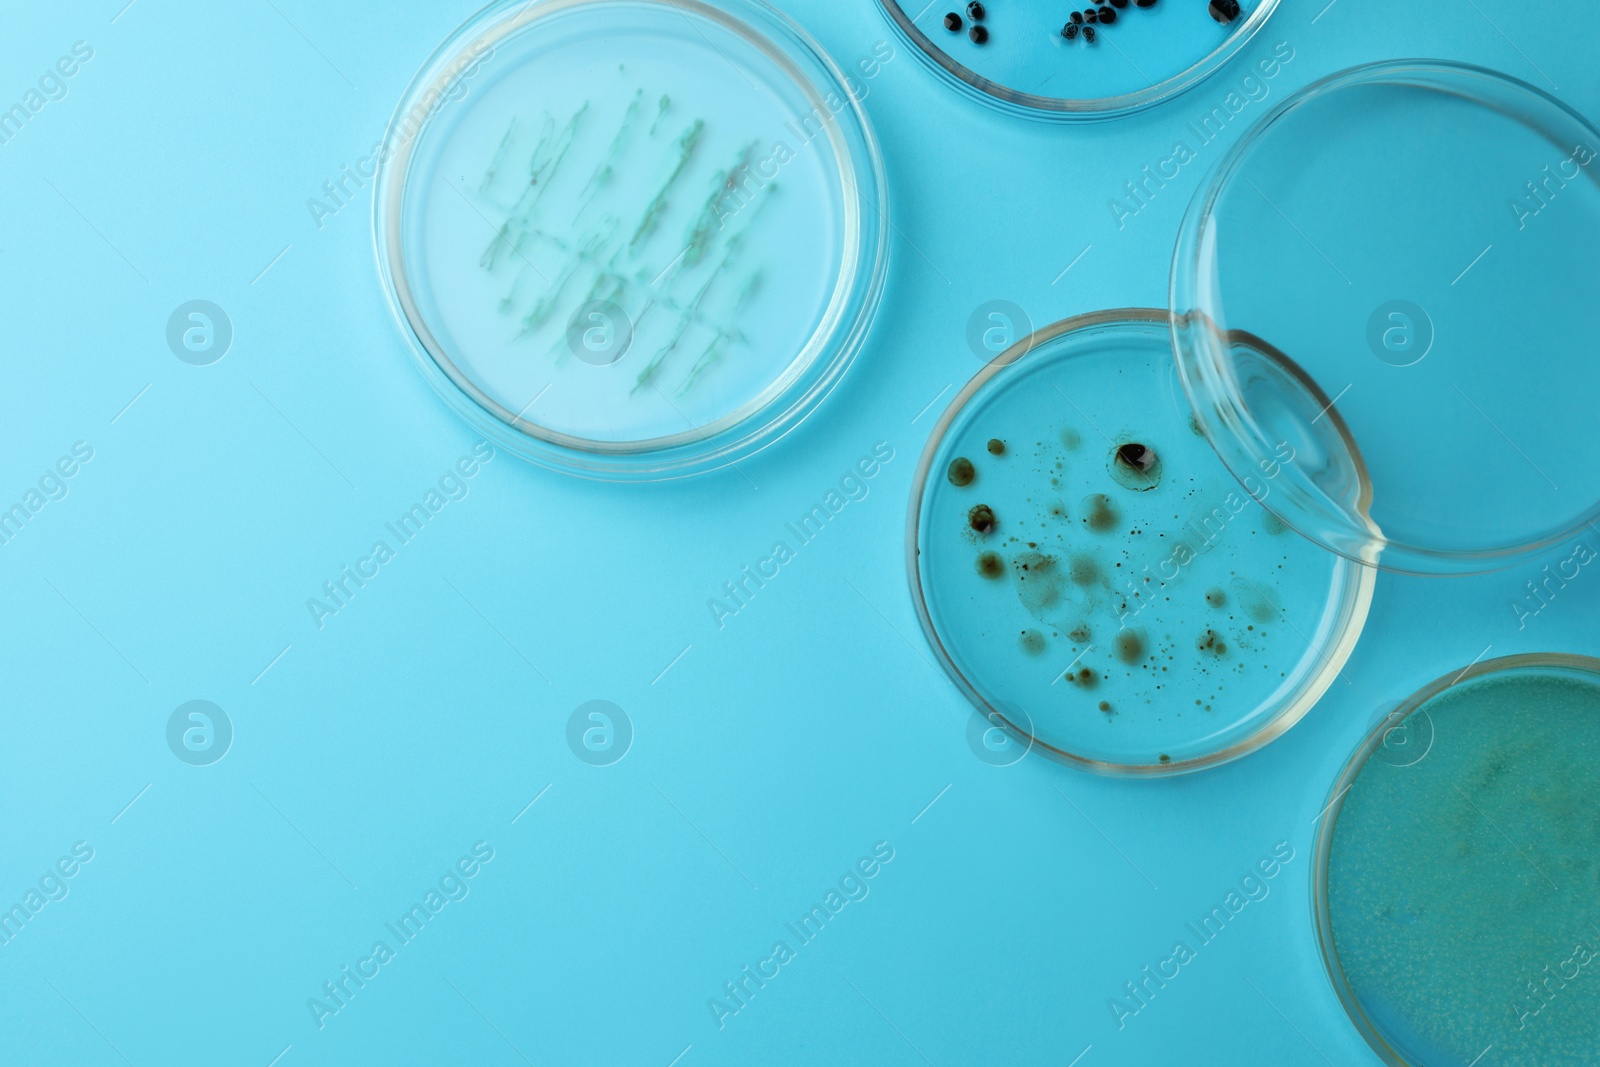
0,0 -> 1600,1067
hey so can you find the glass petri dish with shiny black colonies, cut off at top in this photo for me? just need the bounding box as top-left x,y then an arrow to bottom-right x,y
878,0 -> 1293,122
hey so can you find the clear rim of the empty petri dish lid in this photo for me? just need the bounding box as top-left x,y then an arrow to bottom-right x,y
1168,58 -> 1600,574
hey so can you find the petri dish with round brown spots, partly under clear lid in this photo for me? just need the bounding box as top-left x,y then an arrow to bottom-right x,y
907,309 -> 1374,776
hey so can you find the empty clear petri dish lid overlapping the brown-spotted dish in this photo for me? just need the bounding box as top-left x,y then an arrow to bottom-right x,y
1171,61 -> 1600,574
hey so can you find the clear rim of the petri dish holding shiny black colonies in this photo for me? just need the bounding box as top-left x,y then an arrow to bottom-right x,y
878,0 -> 1278,122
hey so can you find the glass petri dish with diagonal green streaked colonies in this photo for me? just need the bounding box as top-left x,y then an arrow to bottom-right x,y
374,0 -> 888,478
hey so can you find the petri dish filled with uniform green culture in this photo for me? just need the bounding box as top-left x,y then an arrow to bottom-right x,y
1314,654 -> 1600,1067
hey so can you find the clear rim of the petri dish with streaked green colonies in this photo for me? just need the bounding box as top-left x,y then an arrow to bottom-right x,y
373,0 -> 890,480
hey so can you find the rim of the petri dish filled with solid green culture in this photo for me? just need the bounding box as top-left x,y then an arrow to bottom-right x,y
1310,653 -> 1600,1067
